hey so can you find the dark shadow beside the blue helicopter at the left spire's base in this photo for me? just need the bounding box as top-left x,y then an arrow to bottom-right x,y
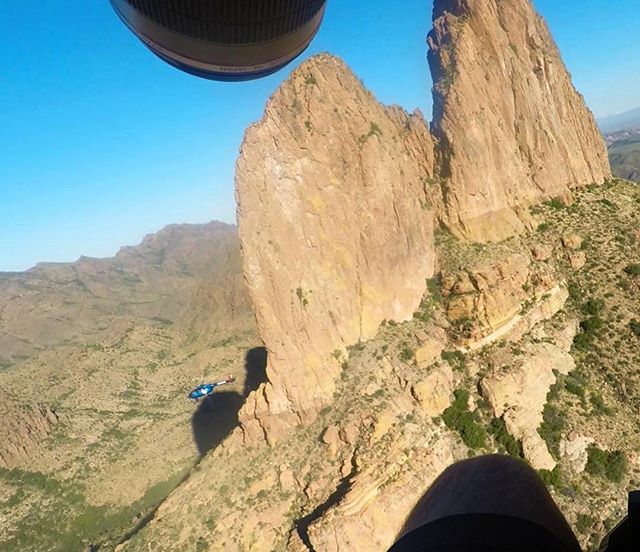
191,347 -> 267,456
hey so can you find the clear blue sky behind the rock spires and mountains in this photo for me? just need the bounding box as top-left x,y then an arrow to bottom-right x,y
0,0 -> 640,270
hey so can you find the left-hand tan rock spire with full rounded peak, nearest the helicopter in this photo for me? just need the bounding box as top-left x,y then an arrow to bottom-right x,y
236,55 -> 435,439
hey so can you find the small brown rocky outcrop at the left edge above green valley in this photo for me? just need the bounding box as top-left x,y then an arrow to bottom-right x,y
0,389 -> 58,469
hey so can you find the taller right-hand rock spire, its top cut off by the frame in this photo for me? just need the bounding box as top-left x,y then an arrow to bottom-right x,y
429,0 -> 611,241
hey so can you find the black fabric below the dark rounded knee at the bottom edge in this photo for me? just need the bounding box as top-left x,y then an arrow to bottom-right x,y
389,514 -> 580,552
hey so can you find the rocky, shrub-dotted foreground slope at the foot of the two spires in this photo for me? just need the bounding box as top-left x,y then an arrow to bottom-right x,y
123,181 -> 640,552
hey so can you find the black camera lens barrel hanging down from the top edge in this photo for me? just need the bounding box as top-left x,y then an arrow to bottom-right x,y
111,0 -> 327,81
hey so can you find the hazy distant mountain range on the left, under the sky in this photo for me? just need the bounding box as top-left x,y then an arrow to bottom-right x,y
0,222 -> 252,368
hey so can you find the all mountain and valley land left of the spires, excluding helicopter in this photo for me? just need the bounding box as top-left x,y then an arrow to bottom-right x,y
0,223 -> 265,551
